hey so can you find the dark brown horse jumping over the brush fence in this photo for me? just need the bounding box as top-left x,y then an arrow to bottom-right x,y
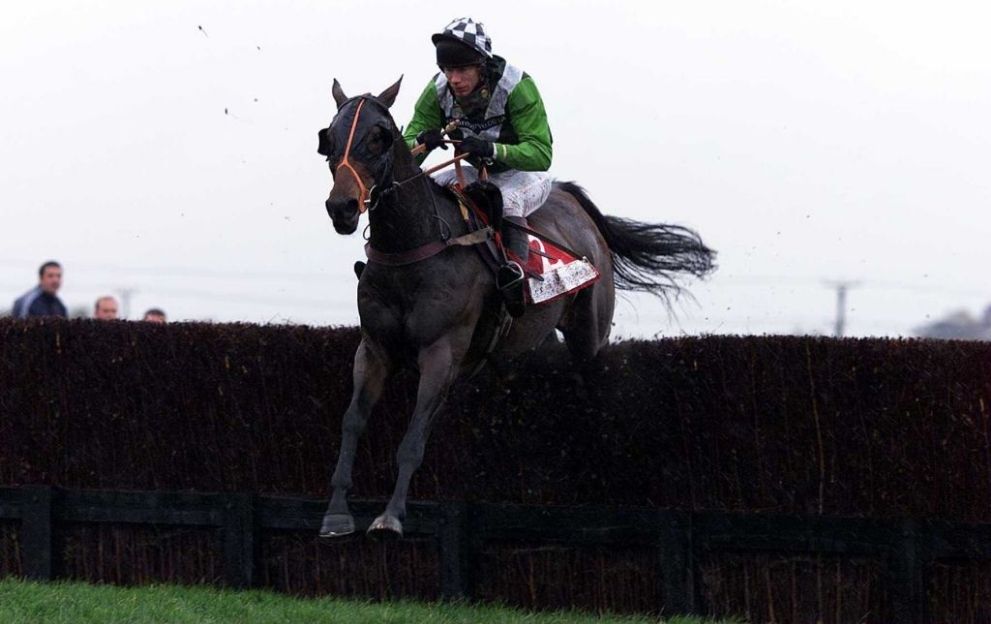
317,78 -> 715,540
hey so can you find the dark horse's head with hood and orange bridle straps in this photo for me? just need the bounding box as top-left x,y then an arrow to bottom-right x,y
317,78 -> 403,234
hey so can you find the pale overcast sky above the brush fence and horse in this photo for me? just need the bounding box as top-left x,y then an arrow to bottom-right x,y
0,0 -> 991,337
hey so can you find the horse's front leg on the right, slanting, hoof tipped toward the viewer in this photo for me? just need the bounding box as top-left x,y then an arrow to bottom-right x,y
368,335 -> 467,538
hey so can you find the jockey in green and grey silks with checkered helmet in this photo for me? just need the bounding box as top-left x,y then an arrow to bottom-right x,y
403,17 -> 553,313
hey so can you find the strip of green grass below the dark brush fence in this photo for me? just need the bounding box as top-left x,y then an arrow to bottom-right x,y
0,578 -> 736,624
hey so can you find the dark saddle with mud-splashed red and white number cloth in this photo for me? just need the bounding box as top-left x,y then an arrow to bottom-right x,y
448,182 -> 599,304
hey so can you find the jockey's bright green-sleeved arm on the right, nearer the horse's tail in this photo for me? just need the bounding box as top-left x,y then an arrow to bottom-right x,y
492,76 -> 554,171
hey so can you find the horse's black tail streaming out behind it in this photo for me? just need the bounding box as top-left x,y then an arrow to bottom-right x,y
559,182 -> 716,297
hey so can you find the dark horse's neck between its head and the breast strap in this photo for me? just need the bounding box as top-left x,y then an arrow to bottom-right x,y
368,138 -> 461,253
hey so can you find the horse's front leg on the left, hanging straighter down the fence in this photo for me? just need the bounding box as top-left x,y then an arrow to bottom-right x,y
320,338 -> 389,538
